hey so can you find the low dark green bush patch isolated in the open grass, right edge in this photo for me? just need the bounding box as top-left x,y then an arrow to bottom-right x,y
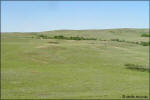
125,64 -> 149,72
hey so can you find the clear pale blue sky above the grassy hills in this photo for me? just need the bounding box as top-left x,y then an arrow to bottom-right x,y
1,1 -> 149,32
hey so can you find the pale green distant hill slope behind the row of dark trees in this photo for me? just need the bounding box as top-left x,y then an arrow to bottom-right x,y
2,28 -> 149,41
